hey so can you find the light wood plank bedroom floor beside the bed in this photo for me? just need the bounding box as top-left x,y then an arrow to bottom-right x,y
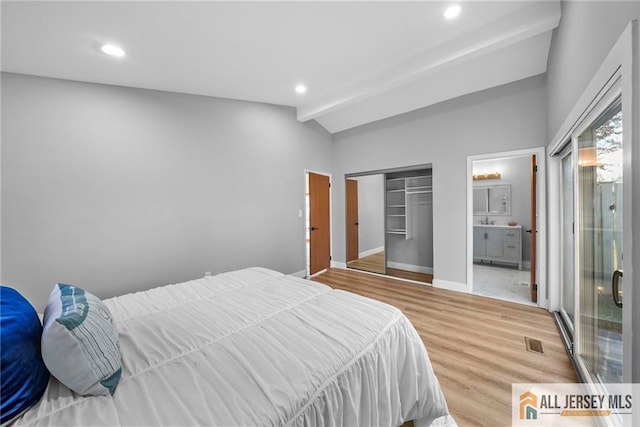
313,269 -> 577,427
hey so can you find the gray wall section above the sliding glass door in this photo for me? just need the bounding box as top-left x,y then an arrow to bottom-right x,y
547,1 -> 640,140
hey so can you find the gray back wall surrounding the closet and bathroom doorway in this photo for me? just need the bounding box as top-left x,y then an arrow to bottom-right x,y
332,76 -> 547,290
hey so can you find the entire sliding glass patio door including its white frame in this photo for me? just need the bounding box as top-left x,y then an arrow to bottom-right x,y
550,23 -> 640,402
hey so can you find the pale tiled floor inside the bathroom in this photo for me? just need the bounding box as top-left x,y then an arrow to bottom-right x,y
473,264 -> 537,306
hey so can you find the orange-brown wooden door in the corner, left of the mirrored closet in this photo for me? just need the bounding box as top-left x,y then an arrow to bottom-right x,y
309,173 -> 331,274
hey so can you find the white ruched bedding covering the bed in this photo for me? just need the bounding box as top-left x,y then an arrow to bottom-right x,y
16,268 -> 455,426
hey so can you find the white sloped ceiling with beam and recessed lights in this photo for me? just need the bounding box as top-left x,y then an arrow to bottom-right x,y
1,0 -> 560,133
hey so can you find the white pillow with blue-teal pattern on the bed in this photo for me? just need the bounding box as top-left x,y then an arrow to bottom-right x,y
42,283 -> 122,396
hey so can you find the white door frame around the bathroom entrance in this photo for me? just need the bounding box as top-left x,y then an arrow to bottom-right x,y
467,147 -> 549,308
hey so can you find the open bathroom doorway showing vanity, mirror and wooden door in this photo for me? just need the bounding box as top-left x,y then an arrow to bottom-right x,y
467,148 -> 547,305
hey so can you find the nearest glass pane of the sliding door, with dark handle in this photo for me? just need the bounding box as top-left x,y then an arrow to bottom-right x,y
576,98 -> 623,383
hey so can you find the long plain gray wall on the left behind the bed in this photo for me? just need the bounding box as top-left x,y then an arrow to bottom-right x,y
2,73 -> 331,309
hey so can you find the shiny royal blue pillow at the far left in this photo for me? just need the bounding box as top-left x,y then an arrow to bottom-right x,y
0,286 -> 49,424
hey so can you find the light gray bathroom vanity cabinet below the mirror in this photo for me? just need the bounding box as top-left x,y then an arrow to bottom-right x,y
473,225 -> 522,270
